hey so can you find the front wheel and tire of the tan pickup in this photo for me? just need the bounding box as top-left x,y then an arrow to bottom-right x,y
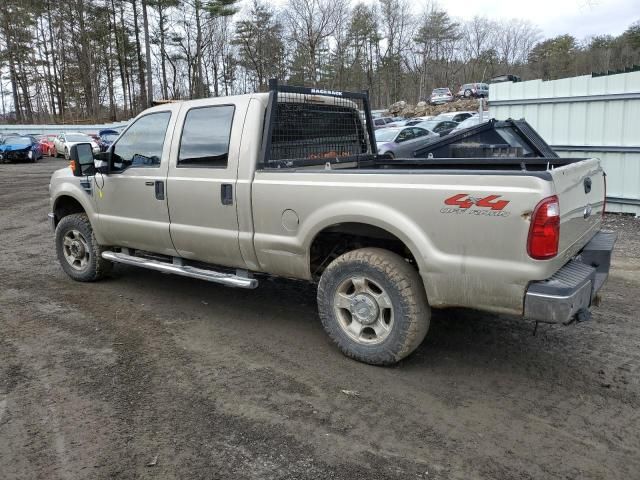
56,213 -> 113,282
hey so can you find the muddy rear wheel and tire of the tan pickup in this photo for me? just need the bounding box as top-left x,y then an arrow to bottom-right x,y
318,248 -> 431,365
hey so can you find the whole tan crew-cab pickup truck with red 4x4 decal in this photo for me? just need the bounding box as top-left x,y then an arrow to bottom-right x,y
49,84 -> 615,364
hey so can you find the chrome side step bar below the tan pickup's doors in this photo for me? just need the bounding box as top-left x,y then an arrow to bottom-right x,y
102,251 -> 258,288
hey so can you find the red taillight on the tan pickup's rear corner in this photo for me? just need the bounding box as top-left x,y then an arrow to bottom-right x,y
527,195 -> 560,260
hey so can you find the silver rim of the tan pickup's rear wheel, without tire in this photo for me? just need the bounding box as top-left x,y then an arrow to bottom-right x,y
333,276 -> 393,345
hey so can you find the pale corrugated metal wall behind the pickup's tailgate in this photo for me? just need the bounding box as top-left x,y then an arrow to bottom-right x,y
489,72 -> 640,215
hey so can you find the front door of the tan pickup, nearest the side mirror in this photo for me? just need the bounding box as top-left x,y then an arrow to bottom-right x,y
95,106 -> 177,255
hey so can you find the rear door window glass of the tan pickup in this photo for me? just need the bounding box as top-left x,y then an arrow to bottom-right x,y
178,105 -> 235,168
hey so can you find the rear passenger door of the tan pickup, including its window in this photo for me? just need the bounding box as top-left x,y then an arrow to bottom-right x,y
167,96 -> 249,267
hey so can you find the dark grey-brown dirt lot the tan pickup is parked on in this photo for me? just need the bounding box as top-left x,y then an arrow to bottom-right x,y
0,159 -> 640,480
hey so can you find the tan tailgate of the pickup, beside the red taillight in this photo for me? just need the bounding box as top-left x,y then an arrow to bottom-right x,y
550,158 -> 605,255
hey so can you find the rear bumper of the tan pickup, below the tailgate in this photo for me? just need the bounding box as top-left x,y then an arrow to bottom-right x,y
524,231 -> 617,323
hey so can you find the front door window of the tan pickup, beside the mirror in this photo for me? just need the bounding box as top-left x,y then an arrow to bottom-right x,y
112,112 -> 171,172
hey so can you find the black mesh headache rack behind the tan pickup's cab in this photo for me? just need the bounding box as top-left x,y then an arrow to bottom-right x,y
259,79 -> 377,169
